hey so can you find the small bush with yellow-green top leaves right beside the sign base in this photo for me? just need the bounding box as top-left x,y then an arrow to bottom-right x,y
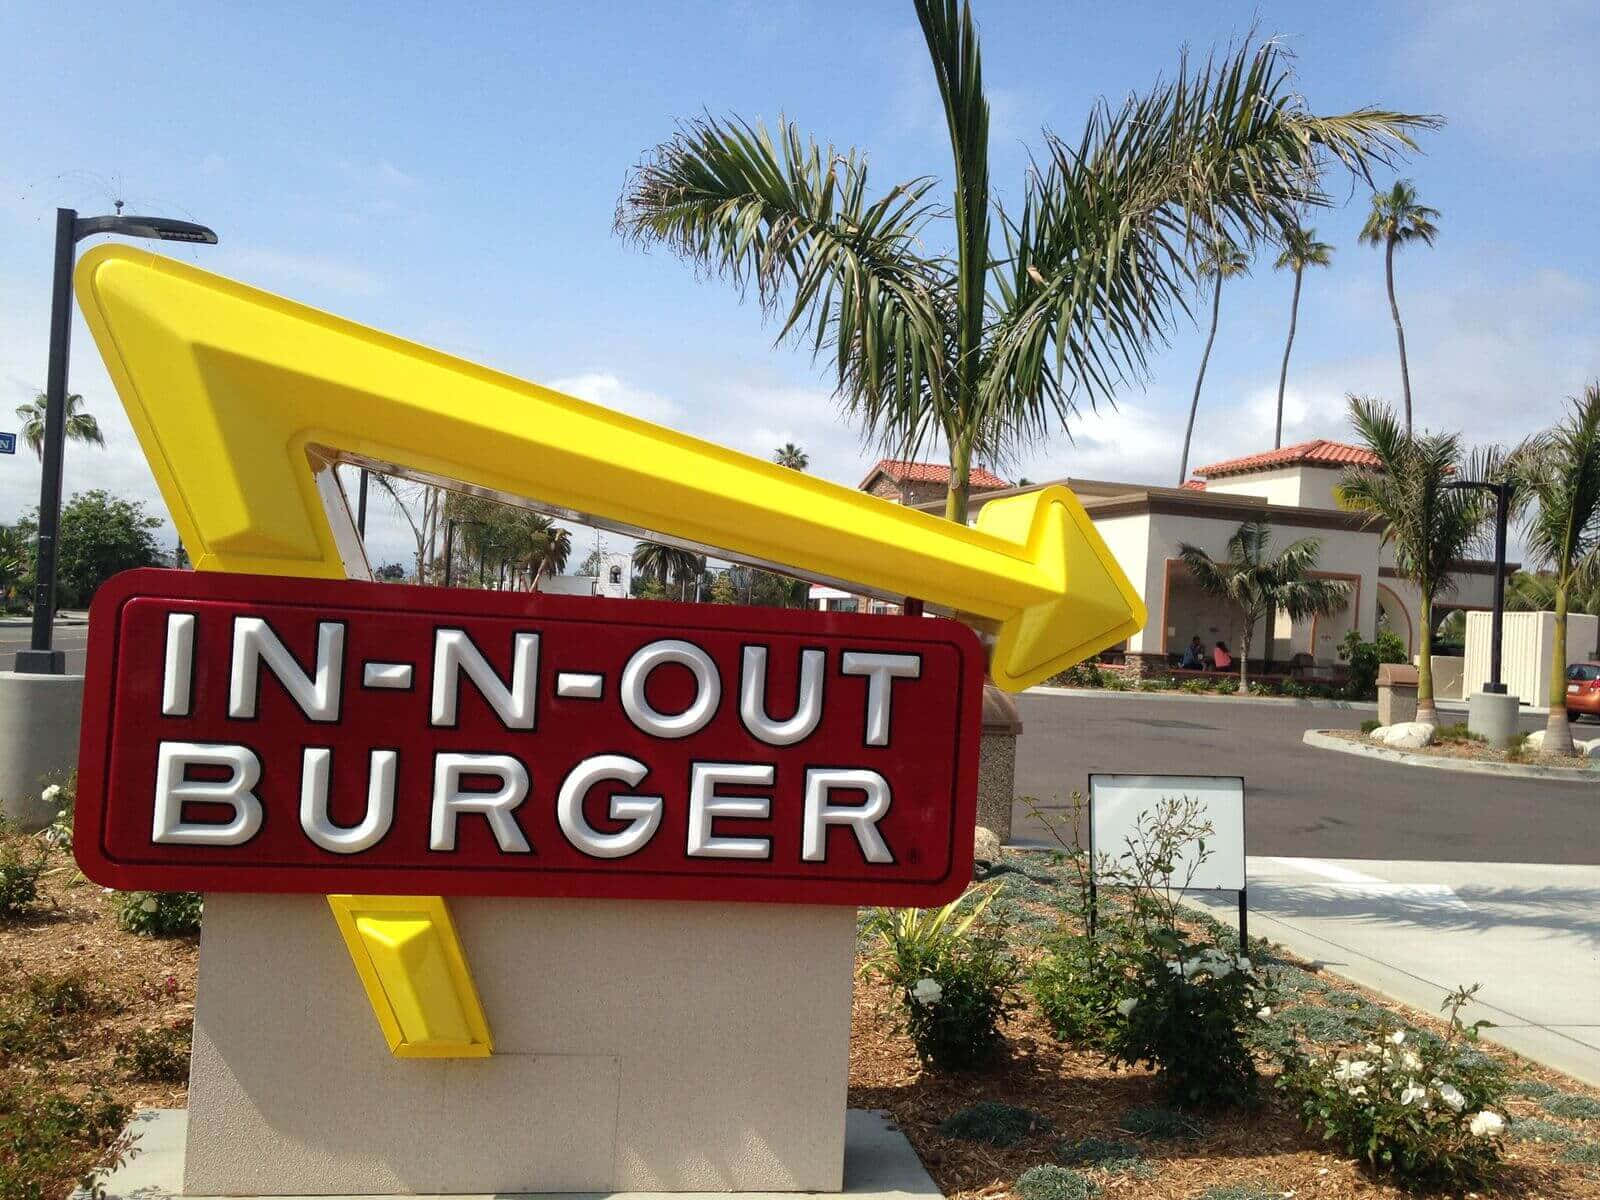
867,890 -> 1019,1070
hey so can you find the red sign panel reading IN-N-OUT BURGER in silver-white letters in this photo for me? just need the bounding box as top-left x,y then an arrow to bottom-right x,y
74,571 -> 982,906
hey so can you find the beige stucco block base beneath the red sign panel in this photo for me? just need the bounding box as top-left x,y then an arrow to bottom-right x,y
184,893 -> 856,1195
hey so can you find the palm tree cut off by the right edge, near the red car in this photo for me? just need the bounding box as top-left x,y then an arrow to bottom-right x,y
1510,382 -> 1600,754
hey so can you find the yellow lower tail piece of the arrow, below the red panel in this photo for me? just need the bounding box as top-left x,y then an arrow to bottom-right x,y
328,896 -> 493,1058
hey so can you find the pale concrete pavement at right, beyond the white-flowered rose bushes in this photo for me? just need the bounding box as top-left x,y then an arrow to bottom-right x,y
1202,857 -> 1600,1086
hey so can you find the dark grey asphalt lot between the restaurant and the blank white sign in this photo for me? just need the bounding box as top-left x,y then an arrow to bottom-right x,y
1011,693 -> 1600,864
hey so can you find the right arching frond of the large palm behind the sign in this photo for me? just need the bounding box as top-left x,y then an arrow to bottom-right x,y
984,42 -> 1440,429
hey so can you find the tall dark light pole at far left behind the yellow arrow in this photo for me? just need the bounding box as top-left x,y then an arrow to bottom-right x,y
16,208 -> 216,675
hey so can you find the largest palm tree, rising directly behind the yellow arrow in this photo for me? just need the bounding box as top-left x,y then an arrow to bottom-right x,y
616,0 -> 1438,522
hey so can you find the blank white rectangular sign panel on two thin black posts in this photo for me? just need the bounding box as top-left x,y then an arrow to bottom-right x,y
1090,774 -> 1245,891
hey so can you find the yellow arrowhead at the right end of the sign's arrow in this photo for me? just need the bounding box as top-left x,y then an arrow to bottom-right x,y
978,486 -> 1146,691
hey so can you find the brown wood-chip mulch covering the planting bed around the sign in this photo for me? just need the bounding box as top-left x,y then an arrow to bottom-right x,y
0,851 -> 1600,1200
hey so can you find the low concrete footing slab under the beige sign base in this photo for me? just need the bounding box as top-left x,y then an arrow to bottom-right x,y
84,1109 -> 941,1200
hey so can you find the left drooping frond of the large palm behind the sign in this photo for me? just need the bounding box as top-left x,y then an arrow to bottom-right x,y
616,117 -> 950,453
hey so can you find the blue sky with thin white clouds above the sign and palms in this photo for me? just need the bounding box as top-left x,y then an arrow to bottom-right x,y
0,0 -> 1600,560
